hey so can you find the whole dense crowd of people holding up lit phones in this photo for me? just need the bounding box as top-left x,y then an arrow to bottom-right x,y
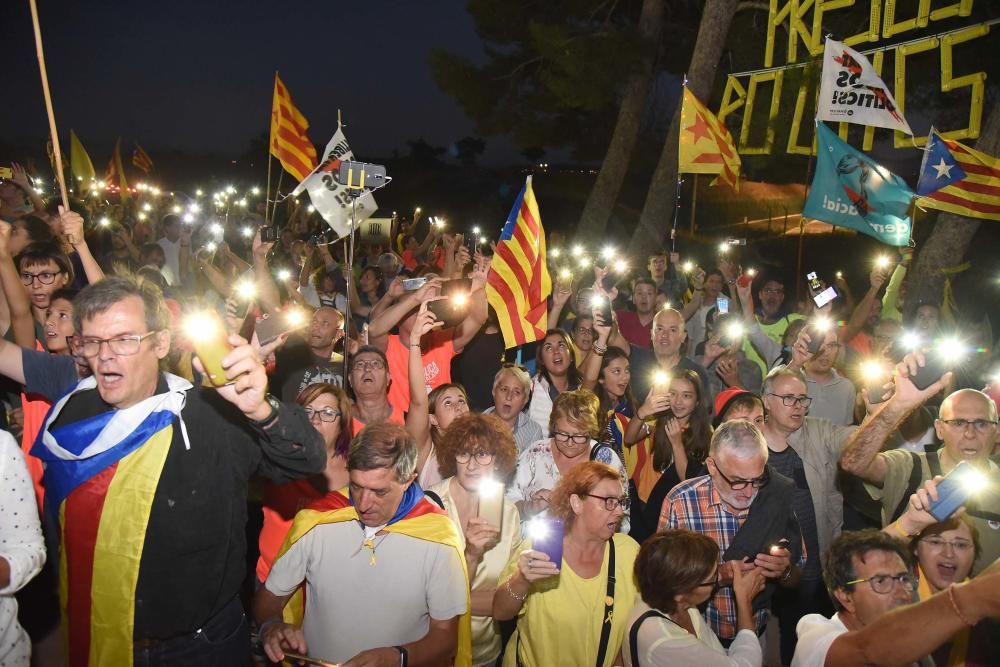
0,165 -> 1000,667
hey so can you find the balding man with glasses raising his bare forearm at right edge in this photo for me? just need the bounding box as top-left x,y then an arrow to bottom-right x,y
840,352 -> 1000,574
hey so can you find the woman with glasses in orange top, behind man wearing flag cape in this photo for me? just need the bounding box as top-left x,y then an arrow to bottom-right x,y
257,382 -> 351,582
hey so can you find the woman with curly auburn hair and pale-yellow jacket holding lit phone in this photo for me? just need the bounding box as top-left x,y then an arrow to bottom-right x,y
429,414 -> 521,665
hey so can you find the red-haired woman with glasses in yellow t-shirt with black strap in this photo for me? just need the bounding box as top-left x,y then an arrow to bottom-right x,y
493,461 -> 639,667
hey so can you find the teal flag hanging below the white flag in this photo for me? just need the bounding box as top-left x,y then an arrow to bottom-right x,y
802,123 -> 914,246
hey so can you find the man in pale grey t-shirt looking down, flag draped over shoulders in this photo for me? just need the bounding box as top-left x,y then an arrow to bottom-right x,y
254,423 -> 472,665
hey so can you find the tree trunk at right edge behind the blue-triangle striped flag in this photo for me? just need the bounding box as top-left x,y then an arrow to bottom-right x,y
906,105 -> 1000,315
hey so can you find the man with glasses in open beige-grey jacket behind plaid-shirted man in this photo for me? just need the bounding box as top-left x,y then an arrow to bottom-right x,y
762,368 -> 854,664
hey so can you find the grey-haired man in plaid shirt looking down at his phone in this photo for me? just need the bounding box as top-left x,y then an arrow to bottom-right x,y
659,420 -> 807,646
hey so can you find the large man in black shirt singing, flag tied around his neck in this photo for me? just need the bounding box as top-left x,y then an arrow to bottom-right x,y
16,277 -> 326,667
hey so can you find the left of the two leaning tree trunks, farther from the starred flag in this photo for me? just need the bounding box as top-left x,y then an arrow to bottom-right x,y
576,0 -> 665,239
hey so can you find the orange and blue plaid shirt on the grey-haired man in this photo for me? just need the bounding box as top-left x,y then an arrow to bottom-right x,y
657,475 -> 805,642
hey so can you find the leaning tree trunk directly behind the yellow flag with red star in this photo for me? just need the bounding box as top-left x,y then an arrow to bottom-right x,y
629,0 -> 739,256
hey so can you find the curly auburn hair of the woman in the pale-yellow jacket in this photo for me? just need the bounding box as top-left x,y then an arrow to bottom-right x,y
435,413 -> 517,479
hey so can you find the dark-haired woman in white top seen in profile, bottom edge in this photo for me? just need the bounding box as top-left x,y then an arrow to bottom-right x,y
622,529 -> 764,667
